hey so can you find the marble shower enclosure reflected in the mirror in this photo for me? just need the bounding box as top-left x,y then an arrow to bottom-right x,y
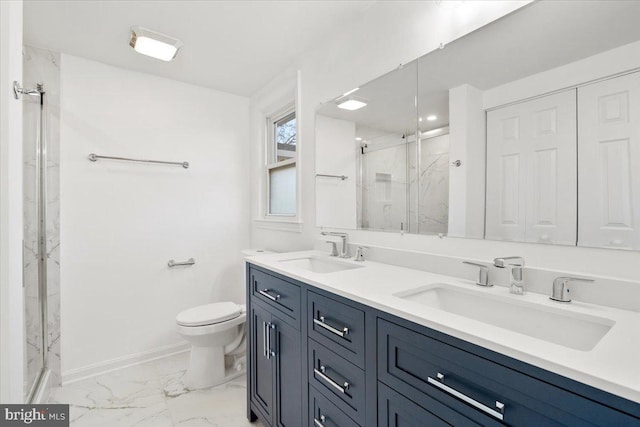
356,133 -> 450,234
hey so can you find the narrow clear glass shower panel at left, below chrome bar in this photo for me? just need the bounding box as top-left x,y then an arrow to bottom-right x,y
22,85 -> 47,401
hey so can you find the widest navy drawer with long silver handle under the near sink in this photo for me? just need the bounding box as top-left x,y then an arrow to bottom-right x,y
378,319 -> 639,426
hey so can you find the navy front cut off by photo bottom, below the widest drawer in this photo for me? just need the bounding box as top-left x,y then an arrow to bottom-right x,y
378,383 -> 480,427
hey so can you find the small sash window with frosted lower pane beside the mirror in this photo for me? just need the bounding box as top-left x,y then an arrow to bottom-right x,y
266,107 -> 298,216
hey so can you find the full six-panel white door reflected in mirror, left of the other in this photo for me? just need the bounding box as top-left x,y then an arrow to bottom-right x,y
486,90 -> 577,245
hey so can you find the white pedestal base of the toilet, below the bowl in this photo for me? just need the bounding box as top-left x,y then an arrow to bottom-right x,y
184,346 -> 246,390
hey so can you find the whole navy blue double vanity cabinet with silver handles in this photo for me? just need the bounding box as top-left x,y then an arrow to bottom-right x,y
247,264 -> 640,427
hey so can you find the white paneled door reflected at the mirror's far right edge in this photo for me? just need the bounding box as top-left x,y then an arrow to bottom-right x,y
578,73 -> 640,249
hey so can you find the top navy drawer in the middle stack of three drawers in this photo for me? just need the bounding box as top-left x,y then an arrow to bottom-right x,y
307,292 -> 364,366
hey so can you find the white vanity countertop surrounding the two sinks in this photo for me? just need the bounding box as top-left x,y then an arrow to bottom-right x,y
246,251 -> 640,403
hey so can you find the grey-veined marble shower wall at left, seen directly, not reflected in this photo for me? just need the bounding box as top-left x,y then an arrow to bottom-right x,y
22,46 -> 60,400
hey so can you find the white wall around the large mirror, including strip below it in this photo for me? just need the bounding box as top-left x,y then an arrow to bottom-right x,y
252,1 -> 640,288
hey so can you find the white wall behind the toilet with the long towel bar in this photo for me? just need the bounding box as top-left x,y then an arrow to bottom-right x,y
60,54 -> 249,380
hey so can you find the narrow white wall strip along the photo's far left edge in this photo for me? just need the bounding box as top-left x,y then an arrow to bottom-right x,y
0,0 -> 24,403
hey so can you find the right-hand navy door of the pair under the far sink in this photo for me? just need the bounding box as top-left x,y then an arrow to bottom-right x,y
271,316 -> 306,427
